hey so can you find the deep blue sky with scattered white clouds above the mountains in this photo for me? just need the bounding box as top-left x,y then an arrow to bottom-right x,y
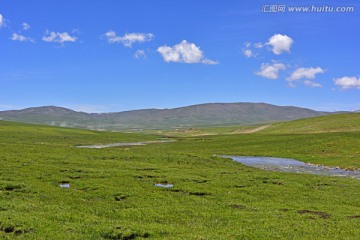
0,0 -> 360,112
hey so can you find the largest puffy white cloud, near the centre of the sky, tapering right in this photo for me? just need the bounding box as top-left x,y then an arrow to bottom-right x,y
157,40 -> 218,64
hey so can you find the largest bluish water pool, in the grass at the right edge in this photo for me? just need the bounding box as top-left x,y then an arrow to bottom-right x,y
222,156 -> 360,179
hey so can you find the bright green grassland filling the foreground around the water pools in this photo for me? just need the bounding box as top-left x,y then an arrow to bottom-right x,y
0,114 -> 360,239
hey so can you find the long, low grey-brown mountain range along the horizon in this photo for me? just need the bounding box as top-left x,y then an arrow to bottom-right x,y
0,103 -> 330,130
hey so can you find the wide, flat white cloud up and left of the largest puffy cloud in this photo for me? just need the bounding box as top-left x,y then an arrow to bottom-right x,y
105,31 -> 154,47
